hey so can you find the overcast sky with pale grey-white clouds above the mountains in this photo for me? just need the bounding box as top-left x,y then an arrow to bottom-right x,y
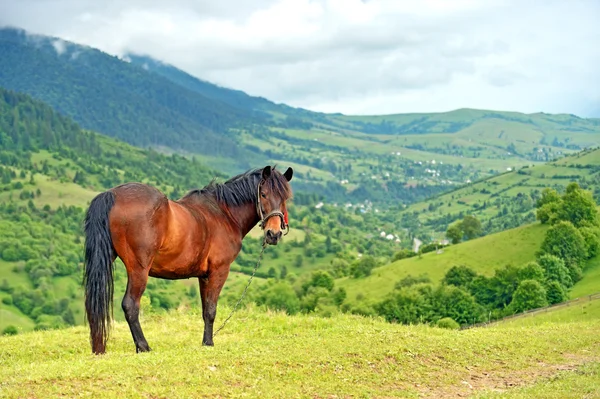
0,0 -> 600,117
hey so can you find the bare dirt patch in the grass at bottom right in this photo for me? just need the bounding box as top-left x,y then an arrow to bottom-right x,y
417,354 -> 600,398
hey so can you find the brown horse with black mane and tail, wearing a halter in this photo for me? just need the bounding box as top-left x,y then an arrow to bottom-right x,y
84,166 -> 293,354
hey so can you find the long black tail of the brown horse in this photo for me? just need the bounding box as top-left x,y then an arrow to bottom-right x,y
83,191 -> 115,354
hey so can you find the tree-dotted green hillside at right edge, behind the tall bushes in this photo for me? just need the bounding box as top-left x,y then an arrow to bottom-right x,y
398,149 -> 600,241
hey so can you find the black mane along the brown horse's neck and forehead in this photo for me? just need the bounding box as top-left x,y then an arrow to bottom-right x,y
181,166 -> 292,207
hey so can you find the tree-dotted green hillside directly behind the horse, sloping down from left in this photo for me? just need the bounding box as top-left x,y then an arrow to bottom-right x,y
0,88 -> 410,331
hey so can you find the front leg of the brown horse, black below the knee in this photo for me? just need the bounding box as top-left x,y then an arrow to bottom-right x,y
199,265 -> 229,346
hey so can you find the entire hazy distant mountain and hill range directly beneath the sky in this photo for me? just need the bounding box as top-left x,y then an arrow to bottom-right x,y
0,29 -> 600,206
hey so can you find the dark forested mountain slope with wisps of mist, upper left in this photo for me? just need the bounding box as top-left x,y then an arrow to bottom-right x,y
0,29 -> 257,164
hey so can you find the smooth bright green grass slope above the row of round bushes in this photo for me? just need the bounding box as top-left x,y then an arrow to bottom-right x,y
336,223 -> 547,301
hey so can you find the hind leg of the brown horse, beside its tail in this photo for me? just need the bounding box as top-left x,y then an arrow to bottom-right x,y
121,262 -> 151,353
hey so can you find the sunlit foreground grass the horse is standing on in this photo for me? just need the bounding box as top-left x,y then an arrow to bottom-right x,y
0,309 -> 600,398
